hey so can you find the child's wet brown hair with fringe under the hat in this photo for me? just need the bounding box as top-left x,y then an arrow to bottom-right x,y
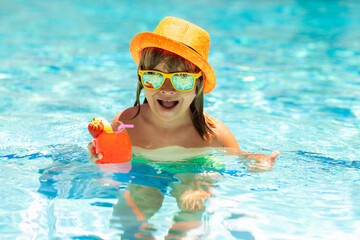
133,48 -> 215,141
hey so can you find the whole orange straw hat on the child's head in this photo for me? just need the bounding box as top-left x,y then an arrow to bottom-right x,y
130,17 -> 216,94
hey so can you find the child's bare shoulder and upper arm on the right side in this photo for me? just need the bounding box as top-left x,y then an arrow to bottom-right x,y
207,114 -> 240,150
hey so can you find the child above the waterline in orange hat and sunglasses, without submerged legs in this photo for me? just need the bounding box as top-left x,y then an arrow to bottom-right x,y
89,17 -> 279,167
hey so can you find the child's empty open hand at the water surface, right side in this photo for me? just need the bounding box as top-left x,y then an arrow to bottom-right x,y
245,151 -> 280,172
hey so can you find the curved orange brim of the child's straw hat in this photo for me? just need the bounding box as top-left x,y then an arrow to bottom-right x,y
130,32 -> 216,94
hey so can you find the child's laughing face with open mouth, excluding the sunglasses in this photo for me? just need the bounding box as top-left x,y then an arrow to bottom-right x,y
144,62 -> 196,122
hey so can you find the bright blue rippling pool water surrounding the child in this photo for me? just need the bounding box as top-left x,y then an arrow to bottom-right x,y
0,0 -> 360,239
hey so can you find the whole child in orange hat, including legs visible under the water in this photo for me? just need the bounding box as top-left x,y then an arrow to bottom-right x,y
89,17 -> 279,238
